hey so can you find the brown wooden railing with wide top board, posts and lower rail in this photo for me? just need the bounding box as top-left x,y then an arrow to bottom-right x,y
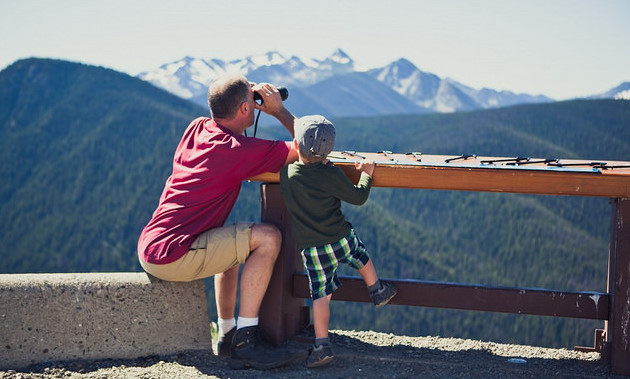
252,152 -> 630,375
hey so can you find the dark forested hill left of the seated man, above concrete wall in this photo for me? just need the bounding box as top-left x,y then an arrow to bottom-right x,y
0,59 -> 207,273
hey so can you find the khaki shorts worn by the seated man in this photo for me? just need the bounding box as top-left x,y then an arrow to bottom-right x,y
140,223 -> 254,282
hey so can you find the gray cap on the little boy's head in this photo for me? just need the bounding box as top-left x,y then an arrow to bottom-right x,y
293,115 -> 335,160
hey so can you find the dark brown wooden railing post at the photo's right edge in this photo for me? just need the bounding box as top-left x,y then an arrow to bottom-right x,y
606,198 -> 630,375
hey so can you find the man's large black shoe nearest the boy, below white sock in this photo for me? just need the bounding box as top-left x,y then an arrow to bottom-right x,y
230,326 -> 304,370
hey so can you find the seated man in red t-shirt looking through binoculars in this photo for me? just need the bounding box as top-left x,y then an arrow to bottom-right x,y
138,75 -> 297,369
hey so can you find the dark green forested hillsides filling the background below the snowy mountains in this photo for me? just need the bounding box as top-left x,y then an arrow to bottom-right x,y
0,59 -> 630,347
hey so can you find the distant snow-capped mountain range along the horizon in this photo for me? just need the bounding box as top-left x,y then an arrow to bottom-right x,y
138,49 -> 630,117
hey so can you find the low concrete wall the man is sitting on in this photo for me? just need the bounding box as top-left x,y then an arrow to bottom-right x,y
0,273 -> 211,369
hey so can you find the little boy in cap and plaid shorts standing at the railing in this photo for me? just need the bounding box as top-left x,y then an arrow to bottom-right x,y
280,116 -> 396,367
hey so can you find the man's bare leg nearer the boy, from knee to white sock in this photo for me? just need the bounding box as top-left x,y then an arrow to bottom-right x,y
239,224 -> 282,318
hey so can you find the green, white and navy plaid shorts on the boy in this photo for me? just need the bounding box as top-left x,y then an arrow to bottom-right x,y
300,229 -> 370,300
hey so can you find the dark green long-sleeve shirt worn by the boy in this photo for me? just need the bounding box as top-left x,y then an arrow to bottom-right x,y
280,162 -> 372,249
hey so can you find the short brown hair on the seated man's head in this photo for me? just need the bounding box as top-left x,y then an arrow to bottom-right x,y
208,75 -> 250,120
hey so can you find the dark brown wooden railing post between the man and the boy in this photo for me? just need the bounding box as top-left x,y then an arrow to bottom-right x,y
259,183 -> 310,345
